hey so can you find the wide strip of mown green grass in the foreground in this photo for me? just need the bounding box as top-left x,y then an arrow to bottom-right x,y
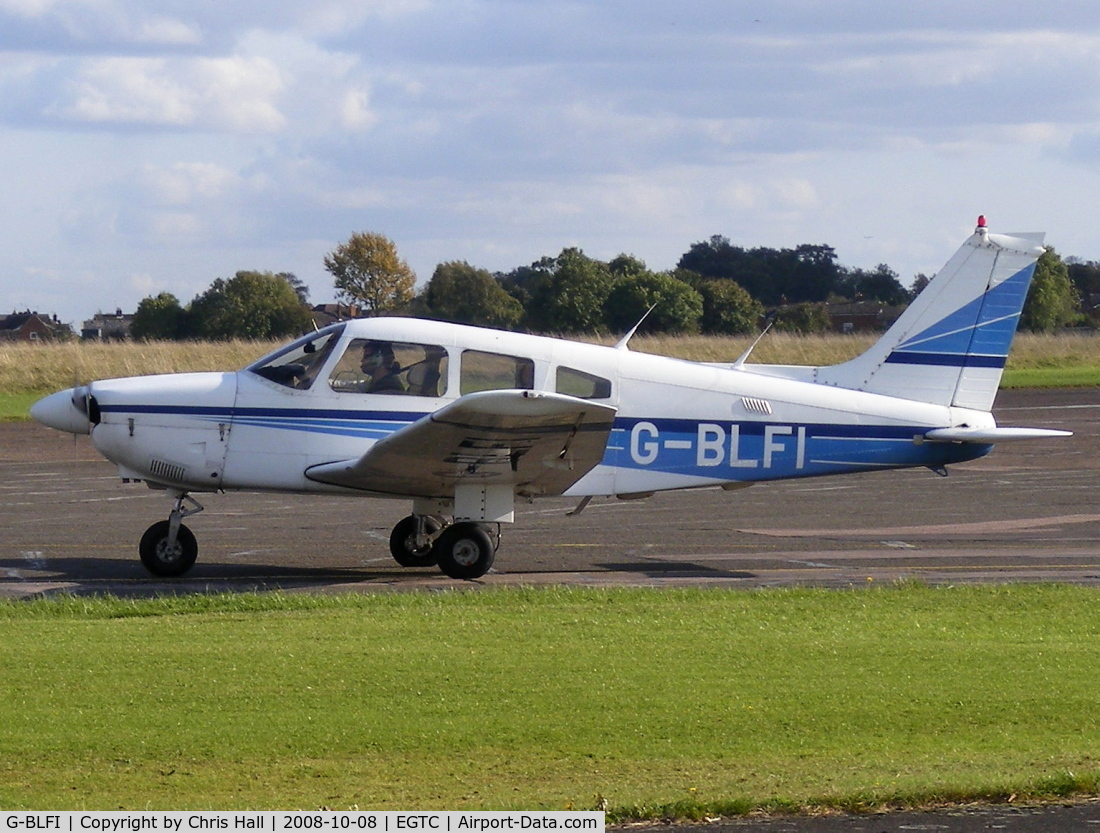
0,584 -> 1100,820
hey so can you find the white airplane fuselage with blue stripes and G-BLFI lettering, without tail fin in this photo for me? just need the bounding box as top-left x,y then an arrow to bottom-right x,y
55,318 -> 993,496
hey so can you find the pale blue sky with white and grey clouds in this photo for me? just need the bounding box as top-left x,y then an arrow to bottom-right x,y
0,0 -> 1100,325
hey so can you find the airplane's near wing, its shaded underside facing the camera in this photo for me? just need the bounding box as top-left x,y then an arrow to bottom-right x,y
306,391 -> 616,497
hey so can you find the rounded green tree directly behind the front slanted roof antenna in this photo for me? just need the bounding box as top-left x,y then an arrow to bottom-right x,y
604,267 -> 703,332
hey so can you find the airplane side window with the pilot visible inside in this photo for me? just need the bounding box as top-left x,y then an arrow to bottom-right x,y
329,339 -> 448,396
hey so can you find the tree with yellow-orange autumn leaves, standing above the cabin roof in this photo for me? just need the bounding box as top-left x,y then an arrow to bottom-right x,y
325,232 -> 416,316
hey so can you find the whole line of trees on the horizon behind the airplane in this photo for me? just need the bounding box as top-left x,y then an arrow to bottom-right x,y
131,232 -> 1086,340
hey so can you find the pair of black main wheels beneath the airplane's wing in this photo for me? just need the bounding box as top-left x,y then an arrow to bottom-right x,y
389,515 -> 501,579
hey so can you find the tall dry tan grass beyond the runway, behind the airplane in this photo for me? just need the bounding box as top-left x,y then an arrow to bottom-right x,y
0,332 -> 1100,393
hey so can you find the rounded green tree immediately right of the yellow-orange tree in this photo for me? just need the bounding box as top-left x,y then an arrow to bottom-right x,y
417,261 -> 524,329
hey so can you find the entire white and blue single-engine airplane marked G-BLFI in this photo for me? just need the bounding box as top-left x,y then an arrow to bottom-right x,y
31,218 -> 1069,579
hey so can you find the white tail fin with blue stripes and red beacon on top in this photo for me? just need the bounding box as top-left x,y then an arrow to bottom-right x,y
816,220 -> 1044,410
